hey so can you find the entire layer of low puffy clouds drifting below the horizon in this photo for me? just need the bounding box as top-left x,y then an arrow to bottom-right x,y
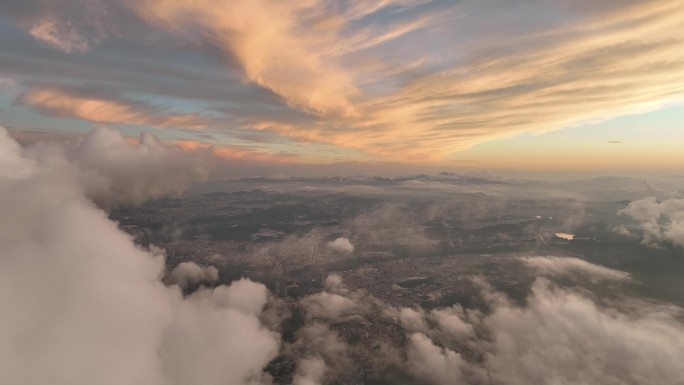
0,127 -> 684,385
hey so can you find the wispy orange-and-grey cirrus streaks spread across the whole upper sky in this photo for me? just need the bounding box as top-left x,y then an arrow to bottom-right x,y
0,0 -> 684,161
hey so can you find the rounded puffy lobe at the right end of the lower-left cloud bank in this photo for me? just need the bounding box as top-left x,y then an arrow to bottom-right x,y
161,281 -> 280,385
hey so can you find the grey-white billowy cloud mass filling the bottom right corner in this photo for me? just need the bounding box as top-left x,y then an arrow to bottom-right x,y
400,278 -> 684,385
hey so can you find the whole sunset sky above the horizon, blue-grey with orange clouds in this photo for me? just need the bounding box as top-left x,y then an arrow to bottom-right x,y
0,0 -> 684,172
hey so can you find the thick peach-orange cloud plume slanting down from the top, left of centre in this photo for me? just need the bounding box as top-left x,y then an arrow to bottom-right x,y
134,0 -> 364,115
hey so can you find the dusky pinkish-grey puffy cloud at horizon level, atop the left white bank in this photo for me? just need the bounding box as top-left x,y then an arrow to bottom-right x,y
3,127 -> 211,206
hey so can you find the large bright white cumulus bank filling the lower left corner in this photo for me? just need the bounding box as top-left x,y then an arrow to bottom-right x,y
0,126 -> 279,385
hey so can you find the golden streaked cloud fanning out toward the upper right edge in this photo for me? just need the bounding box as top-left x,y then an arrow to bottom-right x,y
220,1 -> 684,161
